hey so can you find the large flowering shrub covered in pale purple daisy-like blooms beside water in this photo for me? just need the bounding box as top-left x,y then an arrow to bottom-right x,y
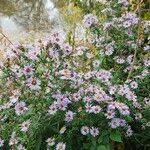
0,0 -> 150,150
